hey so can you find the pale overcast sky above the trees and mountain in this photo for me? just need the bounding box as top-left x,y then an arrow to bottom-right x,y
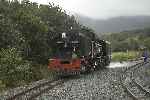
30,0 -> 150,19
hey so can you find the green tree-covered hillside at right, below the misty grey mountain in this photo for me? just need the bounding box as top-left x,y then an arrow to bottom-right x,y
102,28 -> 150,51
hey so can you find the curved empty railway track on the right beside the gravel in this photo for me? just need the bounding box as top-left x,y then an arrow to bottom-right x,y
120,61 -> 150,100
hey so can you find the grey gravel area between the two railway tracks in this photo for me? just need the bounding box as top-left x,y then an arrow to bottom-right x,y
36,68 -> 132,100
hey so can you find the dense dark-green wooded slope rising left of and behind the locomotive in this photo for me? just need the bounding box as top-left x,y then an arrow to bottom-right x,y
0,0 -> 94,92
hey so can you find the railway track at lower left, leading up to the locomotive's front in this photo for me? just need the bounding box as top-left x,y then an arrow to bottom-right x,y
6,79 -> 66,100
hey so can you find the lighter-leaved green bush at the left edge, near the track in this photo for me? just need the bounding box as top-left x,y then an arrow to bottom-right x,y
0,48 -> 32,87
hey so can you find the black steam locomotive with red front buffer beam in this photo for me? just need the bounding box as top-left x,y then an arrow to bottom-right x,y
48,33 -> 111,75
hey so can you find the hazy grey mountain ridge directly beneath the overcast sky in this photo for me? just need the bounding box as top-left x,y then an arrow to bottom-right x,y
76,15 -> 150,33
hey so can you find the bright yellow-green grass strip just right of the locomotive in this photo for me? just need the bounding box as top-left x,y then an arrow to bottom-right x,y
112,51 -> 139,61
